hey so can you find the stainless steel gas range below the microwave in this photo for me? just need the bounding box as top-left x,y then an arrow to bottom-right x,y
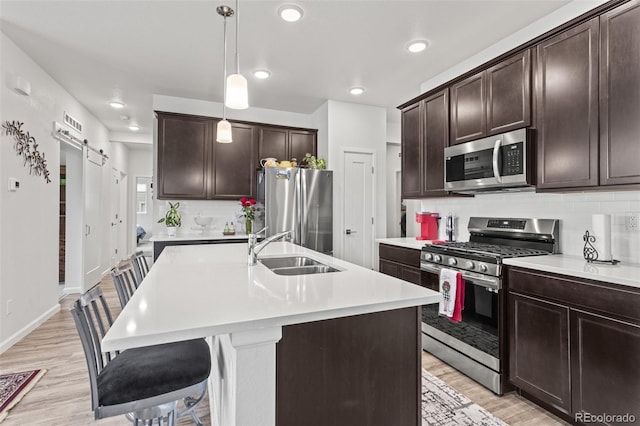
420,217 -> 559,395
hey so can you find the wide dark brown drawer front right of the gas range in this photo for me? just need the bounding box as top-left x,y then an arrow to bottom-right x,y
507,268 -> 640,324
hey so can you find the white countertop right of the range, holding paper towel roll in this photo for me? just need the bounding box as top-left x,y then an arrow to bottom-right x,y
504,254 -> 640,288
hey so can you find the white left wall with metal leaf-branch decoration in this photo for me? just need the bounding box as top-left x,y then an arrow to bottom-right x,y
0,33 -> 126,352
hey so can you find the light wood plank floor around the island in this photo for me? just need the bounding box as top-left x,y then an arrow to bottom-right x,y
0,277 -> 567,426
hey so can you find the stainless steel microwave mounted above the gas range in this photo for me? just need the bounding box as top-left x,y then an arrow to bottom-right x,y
444,129 -> 535,192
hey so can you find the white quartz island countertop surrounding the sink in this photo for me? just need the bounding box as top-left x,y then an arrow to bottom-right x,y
102,242 -> 441,351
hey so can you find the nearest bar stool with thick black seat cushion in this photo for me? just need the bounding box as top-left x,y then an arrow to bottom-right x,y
71,286 -> 211,425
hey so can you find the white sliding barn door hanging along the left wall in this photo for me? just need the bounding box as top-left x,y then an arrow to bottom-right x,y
83,148 -> 103,291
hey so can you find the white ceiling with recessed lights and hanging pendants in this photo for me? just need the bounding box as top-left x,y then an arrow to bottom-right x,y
0,0 -> 569,142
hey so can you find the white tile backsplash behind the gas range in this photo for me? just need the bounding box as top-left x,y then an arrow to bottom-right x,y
406,191 -> 640,263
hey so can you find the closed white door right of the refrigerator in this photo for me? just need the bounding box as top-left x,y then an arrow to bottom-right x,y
342,152 -> 374,268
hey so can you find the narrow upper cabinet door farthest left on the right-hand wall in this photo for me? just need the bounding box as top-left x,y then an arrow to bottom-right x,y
401,102 -> 424,198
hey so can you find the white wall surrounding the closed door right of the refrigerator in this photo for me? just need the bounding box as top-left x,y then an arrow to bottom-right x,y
327,100 -> 387,264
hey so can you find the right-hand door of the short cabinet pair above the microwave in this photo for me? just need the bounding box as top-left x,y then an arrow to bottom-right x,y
486,49 -> 531,135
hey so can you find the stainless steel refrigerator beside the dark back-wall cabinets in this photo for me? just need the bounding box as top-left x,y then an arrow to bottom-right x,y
256,167 -> 333,254
